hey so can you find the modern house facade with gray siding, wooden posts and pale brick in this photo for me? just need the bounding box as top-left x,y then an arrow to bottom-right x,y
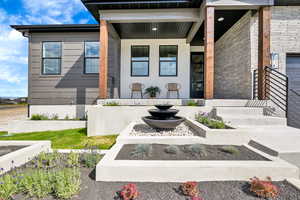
12,0 -> 300,120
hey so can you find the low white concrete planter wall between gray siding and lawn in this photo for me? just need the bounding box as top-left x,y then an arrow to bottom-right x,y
8,120 -> 86,133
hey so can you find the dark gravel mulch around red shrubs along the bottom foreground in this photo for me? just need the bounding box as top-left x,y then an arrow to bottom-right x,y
14,168 -> 300,200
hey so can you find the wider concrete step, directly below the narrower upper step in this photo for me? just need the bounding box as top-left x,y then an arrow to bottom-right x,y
220,114 -> 287,127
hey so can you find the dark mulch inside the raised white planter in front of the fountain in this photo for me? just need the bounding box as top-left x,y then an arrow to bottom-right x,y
116,144 -> 270,161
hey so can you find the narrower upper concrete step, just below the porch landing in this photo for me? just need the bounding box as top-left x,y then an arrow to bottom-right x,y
216,107 -> 264,116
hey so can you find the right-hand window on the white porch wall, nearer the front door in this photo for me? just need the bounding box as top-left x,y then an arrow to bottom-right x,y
159,45 -> 178,76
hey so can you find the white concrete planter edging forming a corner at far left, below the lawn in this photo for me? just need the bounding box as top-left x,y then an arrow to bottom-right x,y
0,141 -> 51,174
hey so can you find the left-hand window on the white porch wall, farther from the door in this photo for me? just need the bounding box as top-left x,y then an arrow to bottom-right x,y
131,46 -> 149,76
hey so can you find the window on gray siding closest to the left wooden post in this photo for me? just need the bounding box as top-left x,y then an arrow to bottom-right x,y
84,42 -> 99,74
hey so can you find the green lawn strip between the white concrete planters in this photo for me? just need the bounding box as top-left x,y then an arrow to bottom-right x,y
0,128 -> 117,149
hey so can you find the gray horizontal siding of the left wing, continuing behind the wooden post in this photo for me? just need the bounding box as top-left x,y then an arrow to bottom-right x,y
29,32 -> 120,105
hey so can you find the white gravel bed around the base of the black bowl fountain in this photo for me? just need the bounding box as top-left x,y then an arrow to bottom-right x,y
130,123 -> 195,136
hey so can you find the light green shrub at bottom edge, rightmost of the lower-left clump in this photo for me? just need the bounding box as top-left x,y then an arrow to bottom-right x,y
53,168 -> 81,199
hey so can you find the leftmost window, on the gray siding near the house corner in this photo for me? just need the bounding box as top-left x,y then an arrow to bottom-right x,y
42,42 -> 61,75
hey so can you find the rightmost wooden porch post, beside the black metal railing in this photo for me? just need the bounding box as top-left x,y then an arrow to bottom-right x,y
258,7 -> 271,100
